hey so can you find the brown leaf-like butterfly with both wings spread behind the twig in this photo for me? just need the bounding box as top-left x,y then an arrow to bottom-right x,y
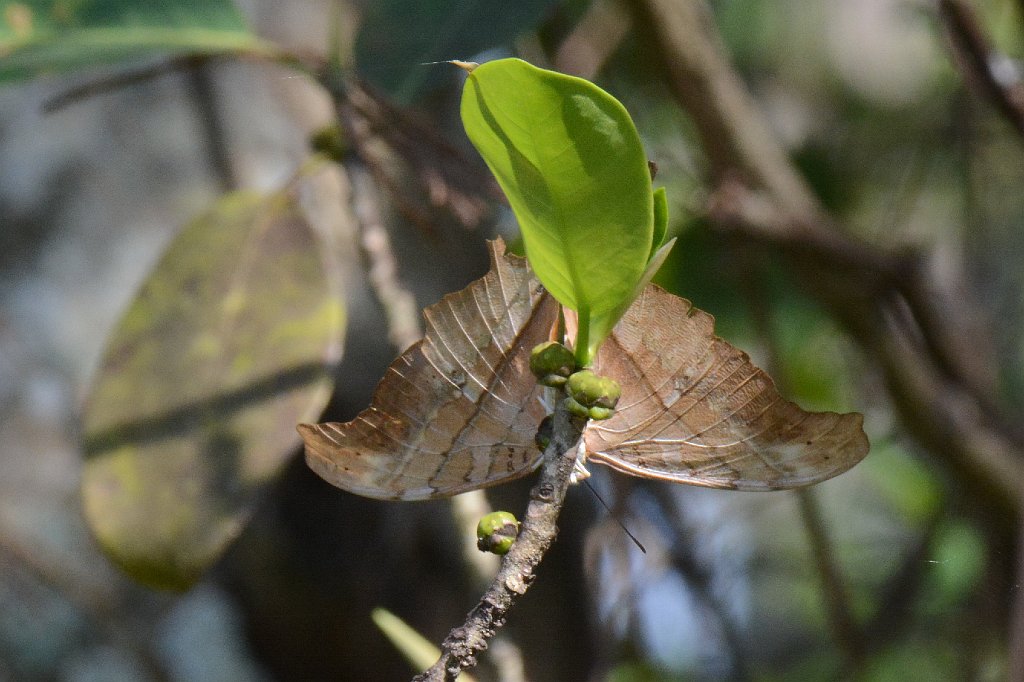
298,240 -> 868,500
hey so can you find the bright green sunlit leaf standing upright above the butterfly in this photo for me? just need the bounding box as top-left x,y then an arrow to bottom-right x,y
462,59 -> 654,366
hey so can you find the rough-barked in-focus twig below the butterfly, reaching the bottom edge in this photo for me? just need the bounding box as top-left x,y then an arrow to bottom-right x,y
416,401 -> 584,682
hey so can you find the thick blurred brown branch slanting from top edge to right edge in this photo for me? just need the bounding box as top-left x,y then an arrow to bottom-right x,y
634,0 -> 1024,516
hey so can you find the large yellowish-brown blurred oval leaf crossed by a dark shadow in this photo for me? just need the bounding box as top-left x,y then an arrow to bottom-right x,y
82,187 -> 344,589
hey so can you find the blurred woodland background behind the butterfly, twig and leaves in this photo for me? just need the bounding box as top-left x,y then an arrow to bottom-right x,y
0,0 -> 1024,682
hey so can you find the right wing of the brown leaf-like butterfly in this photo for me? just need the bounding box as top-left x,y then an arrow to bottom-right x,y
584,285 -> 868,491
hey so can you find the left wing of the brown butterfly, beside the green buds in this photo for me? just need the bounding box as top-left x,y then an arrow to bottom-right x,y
299,241 -> 558,500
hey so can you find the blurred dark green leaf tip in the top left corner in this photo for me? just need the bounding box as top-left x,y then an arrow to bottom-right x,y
0,0 -> 274,83
